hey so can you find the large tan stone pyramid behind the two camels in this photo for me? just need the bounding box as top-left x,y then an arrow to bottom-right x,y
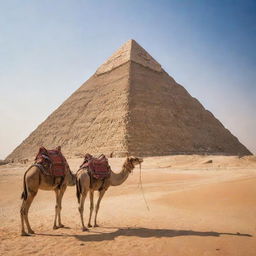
7,40 -> 251,159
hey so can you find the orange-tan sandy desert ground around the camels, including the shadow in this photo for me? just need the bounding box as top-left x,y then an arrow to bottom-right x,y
0,156 -> 256,256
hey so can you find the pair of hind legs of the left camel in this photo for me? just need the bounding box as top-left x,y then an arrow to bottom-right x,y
20,191 -> 37,235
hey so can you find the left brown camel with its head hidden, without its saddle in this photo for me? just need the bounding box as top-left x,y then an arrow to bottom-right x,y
20,162 -> 76,236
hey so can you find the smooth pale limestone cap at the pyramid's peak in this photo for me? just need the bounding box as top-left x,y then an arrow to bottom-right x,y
96,39 -> 162,75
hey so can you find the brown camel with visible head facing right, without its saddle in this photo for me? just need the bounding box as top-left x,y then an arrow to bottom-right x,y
76,157 -> 143,231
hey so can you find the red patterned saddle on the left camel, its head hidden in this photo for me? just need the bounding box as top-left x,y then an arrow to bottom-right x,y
35,146 -> 67,177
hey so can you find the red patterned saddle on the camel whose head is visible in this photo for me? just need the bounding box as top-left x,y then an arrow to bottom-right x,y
80,154 -> 111,180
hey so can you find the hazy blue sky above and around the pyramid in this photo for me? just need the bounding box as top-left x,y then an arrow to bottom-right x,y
0,0 -> 256,159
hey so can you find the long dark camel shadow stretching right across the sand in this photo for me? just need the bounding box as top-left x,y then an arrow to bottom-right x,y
38,227 -> 252,242
